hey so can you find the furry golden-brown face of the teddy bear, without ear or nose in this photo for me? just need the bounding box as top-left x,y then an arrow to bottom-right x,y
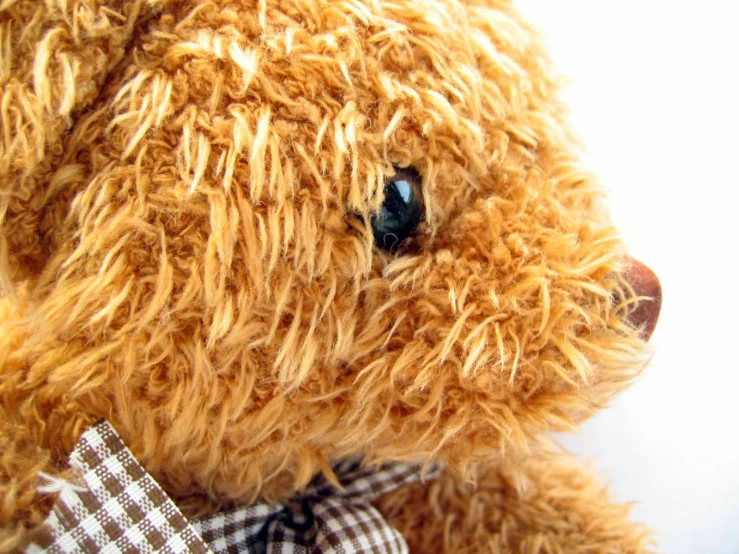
0,0 -> 644,506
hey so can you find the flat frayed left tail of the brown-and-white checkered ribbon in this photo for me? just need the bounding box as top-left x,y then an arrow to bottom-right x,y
26,420 -> 210,554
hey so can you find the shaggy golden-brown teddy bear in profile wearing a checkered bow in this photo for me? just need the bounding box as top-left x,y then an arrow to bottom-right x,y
0,0 -> 659,553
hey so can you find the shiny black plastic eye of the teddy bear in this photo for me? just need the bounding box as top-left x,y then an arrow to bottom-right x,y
372,167 -> 424,250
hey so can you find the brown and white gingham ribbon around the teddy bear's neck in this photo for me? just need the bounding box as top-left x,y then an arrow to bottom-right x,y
26,420 -> 437,554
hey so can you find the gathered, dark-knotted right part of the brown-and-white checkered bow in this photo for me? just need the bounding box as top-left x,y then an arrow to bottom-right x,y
192,459 -> 437,554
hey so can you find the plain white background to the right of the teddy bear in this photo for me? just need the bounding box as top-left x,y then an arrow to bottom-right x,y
518,0 -> 739,554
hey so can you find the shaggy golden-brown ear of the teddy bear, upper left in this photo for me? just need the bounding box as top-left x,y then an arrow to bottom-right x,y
0,0 -> 155,296
